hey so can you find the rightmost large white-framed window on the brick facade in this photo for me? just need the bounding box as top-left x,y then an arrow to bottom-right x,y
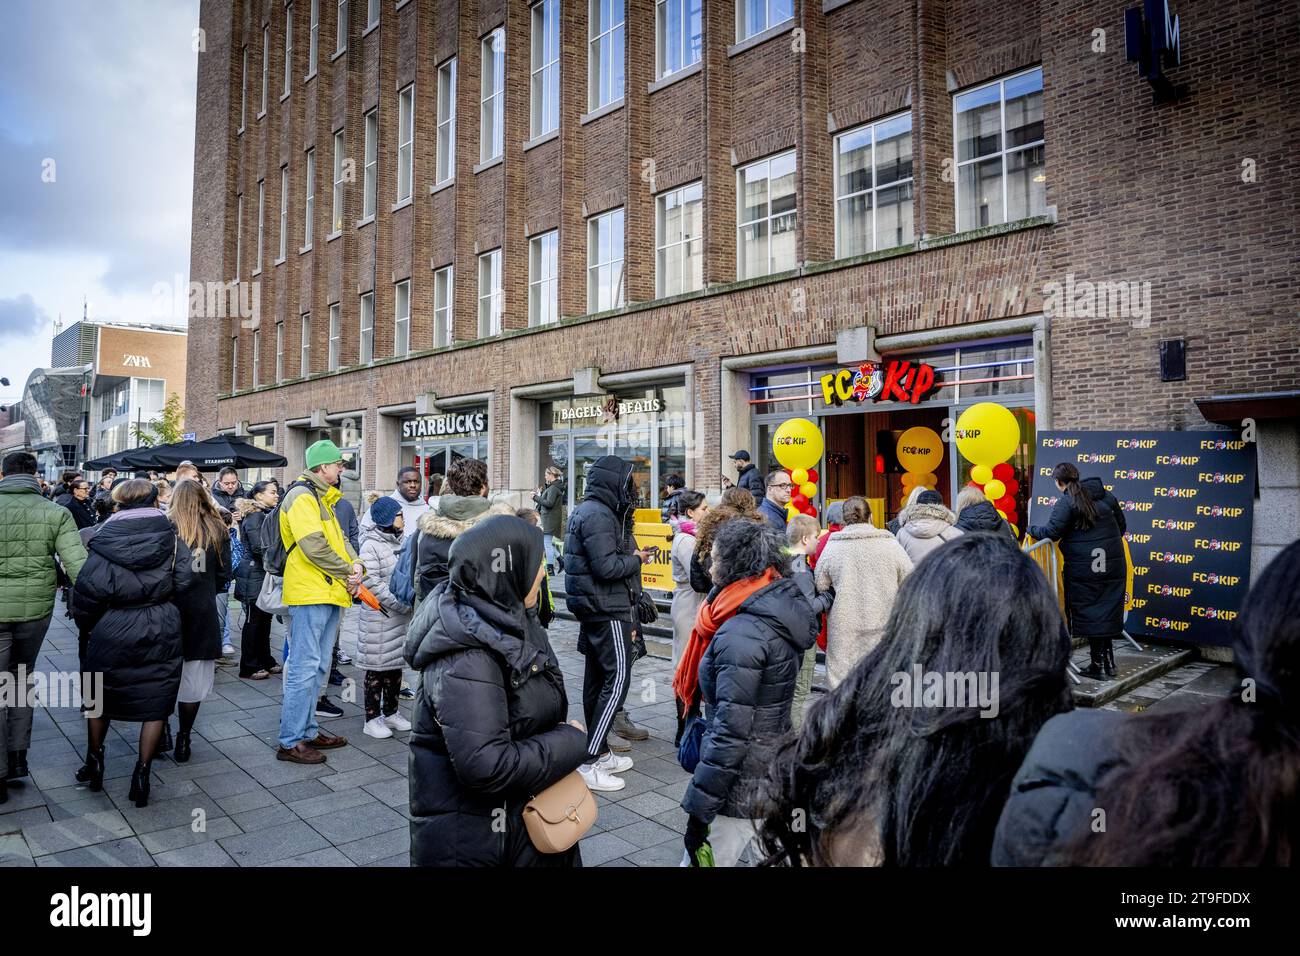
953,68 -> 1048,233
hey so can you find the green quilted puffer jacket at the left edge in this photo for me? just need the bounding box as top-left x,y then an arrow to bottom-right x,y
0,475 -> 86,623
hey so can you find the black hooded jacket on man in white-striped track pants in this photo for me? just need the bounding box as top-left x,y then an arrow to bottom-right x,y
564,455 -> 641,620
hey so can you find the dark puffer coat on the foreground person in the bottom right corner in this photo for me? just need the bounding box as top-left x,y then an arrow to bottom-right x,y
991,710 -> 1132,866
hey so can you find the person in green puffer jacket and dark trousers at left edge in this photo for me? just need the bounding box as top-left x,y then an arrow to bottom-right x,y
0,451 -> 86,804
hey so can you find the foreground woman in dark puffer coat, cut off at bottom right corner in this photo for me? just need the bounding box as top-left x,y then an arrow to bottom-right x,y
992,541 -> 1300,868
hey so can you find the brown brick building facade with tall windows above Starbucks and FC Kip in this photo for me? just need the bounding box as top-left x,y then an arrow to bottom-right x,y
187,0 -> 1300,580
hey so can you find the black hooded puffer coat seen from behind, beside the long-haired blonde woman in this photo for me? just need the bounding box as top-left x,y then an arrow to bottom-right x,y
73,509 -> 194,721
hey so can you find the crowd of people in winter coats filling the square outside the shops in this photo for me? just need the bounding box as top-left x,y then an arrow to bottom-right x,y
0,440 -> 1300,866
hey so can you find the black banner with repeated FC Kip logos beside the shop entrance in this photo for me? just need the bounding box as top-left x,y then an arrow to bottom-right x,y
1028,432 -> 1256,645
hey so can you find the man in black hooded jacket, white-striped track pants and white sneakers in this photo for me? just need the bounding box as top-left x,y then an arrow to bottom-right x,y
564,455 -> 650,791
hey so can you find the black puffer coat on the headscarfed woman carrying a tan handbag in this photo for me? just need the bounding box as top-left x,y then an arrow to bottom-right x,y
406,581 -> 586,866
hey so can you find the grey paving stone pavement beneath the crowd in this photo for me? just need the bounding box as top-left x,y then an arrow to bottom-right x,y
0,605 -> 688,866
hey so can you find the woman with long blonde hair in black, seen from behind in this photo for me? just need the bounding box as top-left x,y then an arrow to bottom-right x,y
166,481 -> 234,763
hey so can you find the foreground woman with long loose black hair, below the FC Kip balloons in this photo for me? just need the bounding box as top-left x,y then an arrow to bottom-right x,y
761,535 -> 1071,866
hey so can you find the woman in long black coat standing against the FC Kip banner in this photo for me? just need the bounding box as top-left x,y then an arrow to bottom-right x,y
1028,462 -> 1127,680
